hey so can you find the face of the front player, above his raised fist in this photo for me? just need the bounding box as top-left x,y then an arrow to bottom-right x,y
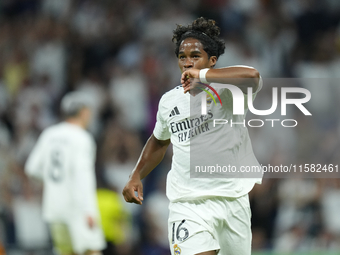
178,38 -> 216,73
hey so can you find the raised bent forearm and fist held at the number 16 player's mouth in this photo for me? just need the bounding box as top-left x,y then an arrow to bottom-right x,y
181,66 -> 260,93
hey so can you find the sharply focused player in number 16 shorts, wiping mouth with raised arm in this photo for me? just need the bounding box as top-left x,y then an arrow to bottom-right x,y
123,18 -> 262,255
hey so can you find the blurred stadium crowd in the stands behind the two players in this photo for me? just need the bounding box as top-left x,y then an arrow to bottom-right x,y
0,0 -> 340,255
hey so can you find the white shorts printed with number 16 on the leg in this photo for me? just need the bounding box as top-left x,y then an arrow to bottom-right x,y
168,194 -> 251,255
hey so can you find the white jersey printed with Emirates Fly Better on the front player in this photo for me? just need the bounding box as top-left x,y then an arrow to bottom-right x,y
153,79 -> 262,202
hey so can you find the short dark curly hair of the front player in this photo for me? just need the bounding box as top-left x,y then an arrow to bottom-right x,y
172,17 -> 225,58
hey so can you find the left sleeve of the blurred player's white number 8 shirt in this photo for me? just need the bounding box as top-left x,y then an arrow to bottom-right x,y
25,133 -> 45,180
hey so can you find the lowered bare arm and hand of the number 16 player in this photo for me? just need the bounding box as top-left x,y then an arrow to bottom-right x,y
123,135 -> 170,204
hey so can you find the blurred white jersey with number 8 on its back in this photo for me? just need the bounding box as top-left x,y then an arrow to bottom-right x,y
25,122 -> 99,223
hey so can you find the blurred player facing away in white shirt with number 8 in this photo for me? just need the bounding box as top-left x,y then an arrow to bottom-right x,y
25,92 -> 105,255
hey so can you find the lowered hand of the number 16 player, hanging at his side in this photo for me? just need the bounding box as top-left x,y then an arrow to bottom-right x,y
122,176 -> 143,205
